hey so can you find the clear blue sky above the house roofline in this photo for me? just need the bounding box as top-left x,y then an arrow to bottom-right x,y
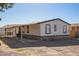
0,3 -> 79,26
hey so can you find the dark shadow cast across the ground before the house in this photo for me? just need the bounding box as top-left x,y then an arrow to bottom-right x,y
1,38 -> 79,48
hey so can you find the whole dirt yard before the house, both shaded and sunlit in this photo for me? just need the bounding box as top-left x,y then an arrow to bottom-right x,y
0,39 -> 79,56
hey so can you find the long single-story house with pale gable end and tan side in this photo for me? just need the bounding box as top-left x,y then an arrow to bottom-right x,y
0,18 -> 70,39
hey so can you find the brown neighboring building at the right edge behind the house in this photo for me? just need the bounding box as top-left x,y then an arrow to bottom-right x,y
70,23 -> 79,38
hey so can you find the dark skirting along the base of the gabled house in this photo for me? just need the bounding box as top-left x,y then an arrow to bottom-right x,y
23,35 -> 69,40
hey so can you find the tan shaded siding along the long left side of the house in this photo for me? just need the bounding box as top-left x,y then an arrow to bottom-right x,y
5,24 -> 41,37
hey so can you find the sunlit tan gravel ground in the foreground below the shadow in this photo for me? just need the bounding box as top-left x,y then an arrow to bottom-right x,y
15,46 -> 79,56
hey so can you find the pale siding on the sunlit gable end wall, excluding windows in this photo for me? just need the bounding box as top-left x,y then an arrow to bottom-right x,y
41,20 -> 69,36
